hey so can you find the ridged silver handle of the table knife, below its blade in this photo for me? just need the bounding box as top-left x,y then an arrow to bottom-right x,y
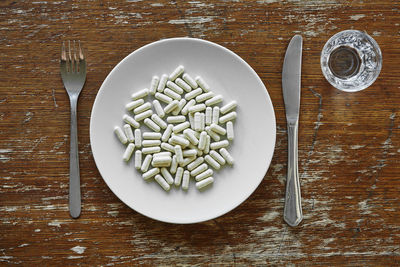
283,120 -> 303,226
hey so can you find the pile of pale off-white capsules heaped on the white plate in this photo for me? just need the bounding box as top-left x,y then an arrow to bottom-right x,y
114,66 -> 237,194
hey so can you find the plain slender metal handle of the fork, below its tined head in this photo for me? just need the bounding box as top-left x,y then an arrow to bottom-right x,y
69,96 -> 81,218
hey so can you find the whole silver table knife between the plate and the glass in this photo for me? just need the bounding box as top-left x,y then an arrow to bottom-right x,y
282,35 -> 303,226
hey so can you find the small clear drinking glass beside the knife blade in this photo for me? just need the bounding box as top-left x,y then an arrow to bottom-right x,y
321,30 -> 382,92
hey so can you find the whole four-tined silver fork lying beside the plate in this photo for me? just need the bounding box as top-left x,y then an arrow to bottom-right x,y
60,41 -> 86,218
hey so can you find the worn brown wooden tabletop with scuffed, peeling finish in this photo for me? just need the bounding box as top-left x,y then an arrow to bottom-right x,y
0,0 -> 400,266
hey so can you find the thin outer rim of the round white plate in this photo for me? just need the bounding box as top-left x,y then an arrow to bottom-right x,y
89,37 -> 276,224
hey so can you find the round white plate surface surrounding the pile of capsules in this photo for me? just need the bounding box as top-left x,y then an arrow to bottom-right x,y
90,38 -> 276,223
